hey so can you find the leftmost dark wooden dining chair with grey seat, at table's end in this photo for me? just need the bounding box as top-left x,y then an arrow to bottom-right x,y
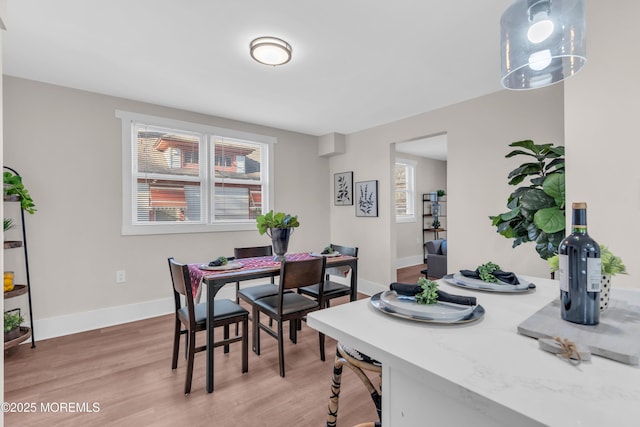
169,257 -> 249,394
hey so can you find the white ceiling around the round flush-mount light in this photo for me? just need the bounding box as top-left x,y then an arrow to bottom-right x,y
3,0 -> 511,135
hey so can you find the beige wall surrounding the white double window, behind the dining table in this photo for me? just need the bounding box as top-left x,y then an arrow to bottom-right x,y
4,76 -> 330,335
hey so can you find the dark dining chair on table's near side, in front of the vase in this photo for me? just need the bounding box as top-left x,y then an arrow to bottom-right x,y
252,257 -> 326,377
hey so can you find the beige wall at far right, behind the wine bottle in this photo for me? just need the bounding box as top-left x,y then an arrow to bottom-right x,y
565,1 -> 640,288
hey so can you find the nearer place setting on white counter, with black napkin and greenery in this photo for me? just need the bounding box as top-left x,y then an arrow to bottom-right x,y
370,277 -> 485,324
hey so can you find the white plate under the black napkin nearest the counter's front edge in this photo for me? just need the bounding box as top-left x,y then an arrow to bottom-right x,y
380,291 -> 474,322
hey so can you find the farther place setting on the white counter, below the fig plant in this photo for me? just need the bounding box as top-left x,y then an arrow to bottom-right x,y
442,261 -> 536,293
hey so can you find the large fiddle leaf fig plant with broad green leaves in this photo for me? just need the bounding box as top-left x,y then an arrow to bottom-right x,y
489,140 -> 566,260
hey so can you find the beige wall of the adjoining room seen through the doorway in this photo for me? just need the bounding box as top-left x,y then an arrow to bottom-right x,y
392,154 -> 447,267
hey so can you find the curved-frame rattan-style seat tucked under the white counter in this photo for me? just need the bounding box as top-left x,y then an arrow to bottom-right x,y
327,342 -> 382,427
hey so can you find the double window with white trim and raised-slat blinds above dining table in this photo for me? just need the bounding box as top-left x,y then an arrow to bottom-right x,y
116,111 -> 275,234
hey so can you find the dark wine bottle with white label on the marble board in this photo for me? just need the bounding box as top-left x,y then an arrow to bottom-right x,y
558,203 -> 602,325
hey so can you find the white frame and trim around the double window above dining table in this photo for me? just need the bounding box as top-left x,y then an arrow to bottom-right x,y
115,110 -> 278,235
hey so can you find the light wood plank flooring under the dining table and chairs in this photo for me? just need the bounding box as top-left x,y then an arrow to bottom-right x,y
4,265 -> 424,427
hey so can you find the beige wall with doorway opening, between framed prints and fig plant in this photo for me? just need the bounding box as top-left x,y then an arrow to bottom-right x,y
330,84 -> 564,296
